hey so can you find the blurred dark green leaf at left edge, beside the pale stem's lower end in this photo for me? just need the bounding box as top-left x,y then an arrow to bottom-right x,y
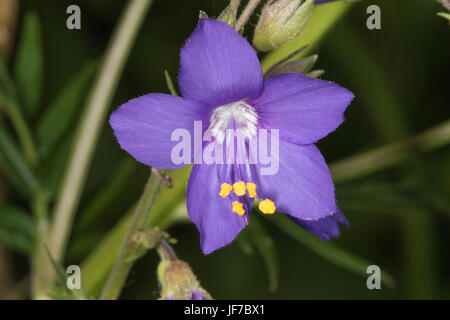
0,204 -> 34,255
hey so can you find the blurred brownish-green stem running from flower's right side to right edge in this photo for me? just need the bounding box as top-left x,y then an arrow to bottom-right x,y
330,120 -> 450,182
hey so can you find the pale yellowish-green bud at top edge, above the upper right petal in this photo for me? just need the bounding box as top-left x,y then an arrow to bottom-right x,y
253,0 -> 314,51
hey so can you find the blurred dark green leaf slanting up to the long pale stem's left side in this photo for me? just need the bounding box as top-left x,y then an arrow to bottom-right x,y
36,62 -> 97,157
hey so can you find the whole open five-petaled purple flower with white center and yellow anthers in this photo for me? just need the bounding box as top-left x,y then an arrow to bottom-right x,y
110,19 -> 353,254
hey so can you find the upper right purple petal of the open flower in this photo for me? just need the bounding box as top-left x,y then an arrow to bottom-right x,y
252,73 -> 353,144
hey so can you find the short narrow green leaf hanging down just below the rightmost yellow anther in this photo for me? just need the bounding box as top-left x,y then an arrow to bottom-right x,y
249,215 -> 279,292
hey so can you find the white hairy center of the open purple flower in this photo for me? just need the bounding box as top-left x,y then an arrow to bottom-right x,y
208,100 -> 258,143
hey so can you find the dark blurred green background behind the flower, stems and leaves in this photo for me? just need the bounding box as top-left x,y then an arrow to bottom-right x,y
0,0 -> 450,299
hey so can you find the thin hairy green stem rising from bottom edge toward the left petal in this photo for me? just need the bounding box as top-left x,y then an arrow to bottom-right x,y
100,174 -> 162,300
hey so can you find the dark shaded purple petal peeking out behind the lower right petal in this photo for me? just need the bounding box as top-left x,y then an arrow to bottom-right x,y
292,208 -> 348,241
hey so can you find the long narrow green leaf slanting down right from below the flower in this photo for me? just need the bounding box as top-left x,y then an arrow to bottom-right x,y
269,215 -> 395,287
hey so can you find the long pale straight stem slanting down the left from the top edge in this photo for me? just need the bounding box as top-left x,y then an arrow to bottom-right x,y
37,0 -> 152,296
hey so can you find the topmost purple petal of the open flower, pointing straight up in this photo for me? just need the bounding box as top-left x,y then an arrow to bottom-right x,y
178,19 -> 263,106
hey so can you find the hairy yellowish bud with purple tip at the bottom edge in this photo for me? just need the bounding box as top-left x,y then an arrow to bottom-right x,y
158,259 -> 212,300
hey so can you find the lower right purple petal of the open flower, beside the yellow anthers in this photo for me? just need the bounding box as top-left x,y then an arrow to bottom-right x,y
251,140 -> 336,220
